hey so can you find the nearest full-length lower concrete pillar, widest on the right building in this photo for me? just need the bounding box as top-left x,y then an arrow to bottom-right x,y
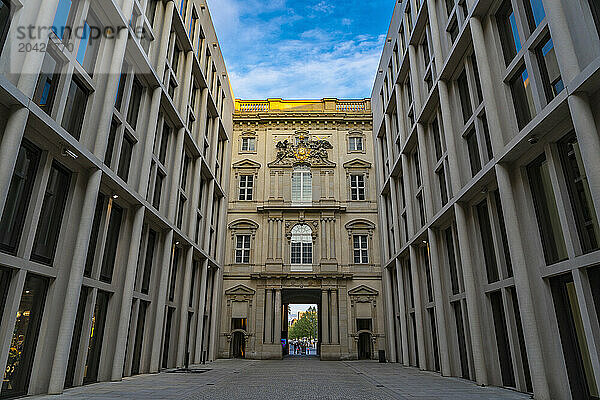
496,164 -> 551,400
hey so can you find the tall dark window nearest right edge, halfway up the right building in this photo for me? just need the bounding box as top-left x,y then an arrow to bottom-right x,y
558,132 -> 600,253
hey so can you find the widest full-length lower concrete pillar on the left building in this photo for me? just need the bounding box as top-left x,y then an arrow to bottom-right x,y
47,169 -> 101,394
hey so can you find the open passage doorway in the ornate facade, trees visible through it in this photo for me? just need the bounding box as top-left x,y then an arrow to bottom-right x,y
281,289 -> 321,357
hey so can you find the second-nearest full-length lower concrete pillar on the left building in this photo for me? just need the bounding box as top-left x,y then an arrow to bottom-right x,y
111,206 -> 144,381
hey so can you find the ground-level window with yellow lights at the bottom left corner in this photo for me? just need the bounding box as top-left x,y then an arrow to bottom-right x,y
2,274 -> 48,398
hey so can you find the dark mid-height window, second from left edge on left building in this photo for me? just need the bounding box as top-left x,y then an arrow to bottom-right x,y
31,162 -> 71,265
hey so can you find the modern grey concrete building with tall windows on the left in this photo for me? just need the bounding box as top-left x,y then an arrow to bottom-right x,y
0,0 -> 234,398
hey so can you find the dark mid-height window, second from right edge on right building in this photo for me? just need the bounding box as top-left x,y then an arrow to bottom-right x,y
527,154 -> 567,265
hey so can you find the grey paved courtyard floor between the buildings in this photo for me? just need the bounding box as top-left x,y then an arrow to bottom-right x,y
34,357 -> 530,400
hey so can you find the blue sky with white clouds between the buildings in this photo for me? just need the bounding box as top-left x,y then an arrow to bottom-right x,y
207,0 -> 395,99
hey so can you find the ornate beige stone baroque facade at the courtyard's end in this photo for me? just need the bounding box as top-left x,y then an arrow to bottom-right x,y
219,99 -> 385,360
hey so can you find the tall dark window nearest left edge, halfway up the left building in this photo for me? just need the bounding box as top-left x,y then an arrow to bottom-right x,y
0,140 -> 40,255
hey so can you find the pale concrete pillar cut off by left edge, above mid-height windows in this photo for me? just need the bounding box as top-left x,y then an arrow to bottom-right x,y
0,108 -> 28,216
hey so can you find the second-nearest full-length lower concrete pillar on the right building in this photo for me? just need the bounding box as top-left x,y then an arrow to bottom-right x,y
454,203 -> 489,385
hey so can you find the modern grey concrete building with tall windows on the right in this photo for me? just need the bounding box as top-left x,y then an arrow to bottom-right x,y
372,0 -> 600,400
